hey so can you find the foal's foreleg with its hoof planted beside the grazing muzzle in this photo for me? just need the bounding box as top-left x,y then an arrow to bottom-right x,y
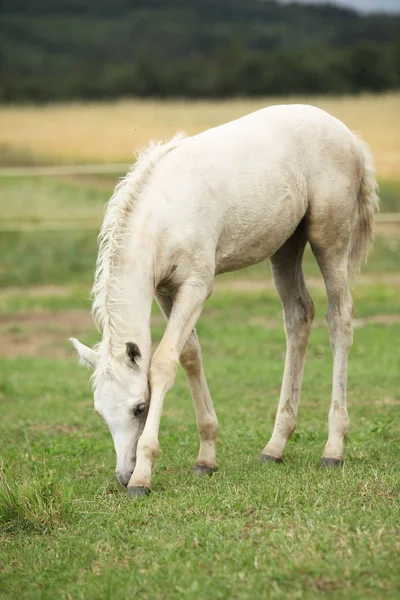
128,280 -> 211,496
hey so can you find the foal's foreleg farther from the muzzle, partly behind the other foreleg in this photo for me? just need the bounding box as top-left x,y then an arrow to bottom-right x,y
156,295 -> 218,474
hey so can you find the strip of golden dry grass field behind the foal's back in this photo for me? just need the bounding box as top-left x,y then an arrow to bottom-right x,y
0,93 -> 400,180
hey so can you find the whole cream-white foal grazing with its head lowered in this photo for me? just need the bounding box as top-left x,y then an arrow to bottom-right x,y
72,105 -> 378,496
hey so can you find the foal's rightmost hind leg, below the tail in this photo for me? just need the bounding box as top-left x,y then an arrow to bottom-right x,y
313,247 -> 353,467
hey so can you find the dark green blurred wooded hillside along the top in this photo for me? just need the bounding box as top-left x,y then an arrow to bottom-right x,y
0,0 -> 400,102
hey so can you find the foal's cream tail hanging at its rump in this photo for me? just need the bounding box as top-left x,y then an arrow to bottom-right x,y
349,137 -> 379,273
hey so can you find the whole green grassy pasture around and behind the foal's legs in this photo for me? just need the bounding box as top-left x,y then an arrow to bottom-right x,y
0,170 -> 400,600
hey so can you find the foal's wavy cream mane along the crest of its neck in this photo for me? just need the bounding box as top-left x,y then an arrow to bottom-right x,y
92,133 -> 185,356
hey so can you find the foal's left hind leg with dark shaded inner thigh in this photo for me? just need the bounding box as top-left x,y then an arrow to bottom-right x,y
260,223 -> 315,462
